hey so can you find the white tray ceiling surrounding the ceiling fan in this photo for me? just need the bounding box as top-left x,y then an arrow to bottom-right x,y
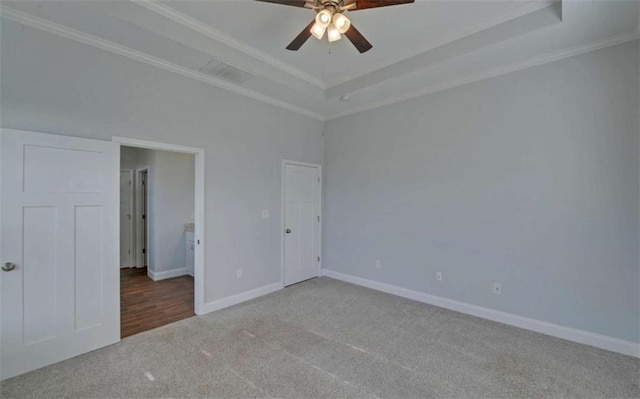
1,0 -> 640,119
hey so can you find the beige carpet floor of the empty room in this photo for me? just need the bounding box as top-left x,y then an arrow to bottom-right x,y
0,278 -> 640,399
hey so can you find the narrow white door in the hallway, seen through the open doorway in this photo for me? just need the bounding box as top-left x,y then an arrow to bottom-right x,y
120,170 -> 135,268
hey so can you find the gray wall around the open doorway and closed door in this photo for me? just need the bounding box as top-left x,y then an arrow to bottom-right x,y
0,20 -> 323,301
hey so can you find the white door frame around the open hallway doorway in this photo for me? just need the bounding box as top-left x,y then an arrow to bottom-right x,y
111,136 -> 206,314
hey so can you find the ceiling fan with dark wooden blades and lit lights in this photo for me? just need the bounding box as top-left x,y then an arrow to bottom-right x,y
256,0 -> 415,53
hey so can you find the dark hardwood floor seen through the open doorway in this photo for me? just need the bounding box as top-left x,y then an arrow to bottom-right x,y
120,267 -> 195,338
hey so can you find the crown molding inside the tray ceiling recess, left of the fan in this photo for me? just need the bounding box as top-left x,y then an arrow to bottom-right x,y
130,0 -> 326,90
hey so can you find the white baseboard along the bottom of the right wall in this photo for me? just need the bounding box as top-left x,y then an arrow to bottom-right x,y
322,269 -> 640,358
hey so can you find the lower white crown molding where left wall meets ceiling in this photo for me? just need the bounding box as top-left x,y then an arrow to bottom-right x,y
0,6 -> 325,121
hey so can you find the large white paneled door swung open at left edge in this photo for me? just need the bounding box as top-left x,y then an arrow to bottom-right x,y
0,129 -> 120,379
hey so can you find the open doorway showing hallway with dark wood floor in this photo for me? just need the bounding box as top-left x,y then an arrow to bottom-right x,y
114,139 -> 204,338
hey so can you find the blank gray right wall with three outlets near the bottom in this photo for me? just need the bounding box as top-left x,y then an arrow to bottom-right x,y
323,42 -> 640,342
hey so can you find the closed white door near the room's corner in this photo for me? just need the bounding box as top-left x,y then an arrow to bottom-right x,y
283,163 -> 320,286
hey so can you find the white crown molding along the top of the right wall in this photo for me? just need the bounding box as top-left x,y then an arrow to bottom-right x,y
325,28 -> 640,121
